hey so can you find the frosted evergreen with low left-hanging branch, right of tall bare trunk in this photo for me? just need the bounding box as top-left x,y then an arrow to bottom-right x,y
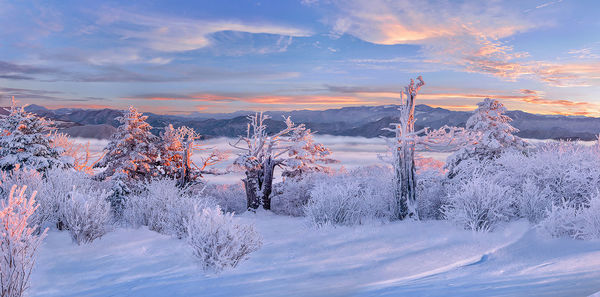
447,98 -> 527,178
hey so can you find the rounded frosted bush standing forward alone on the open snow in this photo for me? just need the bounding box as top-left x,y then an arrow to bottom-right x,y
187,206 -> 262,272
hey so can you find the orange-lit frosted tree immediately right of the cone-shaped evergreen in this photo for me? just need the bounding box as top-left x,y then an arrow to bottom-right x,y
160,125 -> 227,187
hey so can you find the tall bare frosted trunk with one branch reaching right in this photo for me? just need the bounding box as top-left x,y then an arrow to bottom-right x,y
386,76 -> 472,219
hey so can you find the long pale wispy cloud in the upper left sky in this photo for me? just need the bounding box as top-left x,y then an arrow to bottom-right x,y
99,9 -> 312,52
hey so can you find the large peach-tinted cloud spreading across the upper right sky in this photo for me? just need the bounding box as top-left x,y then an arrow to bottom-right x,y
312,0 -> 600,86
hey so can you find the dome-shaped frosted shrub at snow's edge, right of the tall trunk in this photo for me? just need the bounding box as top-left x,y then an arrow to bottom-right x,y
442,177 -> 514,231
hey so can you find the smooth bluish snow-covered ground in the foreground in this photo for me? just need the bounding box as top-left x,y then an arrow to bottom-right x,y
30,213 -> 600,296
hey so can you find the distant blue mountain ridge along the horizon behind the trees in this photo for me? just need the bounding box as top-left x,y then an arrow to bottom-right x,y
21,104 -> 600,140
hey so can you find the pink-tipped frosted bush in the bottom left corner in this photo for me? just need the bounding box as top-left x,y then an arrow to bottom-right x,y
0,185 -> 46,297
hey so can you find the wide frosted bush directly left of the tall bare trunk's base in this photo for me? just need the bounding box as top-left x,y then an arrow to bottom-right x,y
304,166 -> 395,226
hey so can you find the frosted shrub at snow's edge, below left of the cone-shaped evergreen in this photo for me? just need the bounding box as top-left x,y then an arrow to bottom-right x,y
60,188 -> 111,244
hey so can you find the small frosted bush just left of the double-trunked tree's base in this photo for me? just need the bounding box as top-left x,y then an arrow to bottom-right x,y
204,183 -> 246,213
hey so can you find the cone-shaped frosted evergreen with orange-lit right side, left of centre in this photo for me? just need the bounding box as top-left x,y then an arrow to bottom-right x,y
94,106 -> 159,182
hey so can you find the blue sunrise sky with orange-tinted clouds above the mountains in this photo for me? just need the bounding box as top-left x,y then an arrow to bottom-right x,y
0,0 -> 600,116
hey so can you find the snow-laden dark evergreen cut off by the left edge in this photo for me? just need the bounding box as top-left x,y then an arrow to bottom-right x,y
0,99 -> 73,172
